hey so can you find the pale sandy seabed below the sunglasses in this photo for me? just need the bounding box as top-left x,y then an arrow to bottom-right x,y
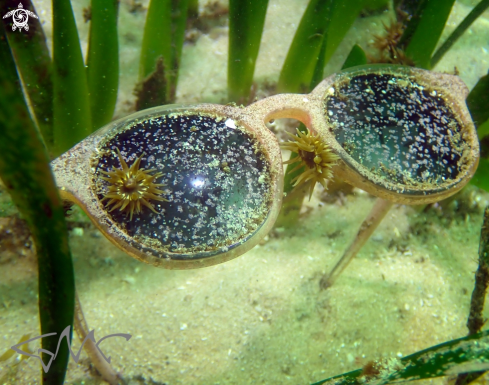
0,187 -> 489,384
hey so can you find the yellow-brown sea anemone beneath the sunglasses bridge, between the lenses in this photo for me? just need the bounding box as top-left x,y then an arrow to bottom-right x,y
280,128 -> 339,199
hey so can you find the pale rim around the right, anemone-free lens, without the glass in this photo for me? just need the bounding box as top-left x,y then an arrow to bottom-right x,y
311,65 -> 479,204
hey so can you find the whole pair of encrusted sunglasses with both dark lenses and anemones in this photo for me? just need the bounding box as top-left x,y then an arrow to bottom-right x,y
52,65 -> 479,269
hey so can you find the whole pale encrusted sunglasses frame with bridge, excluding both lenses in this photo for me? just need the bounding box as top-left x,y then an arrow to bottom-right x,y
52,65 -> 479,269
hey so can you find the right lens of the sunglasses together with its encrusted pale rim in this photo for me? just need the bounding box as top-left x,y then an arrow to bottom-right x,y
313,66 -> 479,204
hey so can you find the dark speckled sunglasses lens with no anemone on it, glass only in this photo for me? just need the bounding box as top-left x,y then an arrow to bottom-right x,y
325,72 -> 470,188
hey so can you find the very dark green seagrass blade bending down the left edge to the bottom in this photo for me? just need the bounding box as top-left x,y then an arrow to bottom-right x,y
0,19 -> 75,385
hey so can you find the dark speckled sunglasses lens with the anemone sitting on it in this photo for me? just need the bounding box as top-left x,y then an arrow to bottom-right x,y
93,112 -> 272,260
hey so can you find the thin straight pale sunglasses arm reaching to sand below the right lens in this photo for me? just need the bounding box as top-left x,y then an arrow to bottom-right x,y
319,198 -> 393,290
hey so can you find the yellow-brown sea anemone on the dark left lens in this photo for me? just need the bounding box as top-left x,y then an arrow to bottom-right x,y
100,148 -> 168,220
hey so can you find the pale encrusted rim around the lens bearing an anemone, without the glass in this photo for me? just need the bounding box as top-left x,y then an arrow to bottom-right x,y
52,104 -> 283,269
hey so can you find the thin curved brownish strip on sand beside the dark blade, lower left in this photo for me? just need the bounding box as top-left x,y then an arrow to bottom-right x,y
73,293 -> 124,385
